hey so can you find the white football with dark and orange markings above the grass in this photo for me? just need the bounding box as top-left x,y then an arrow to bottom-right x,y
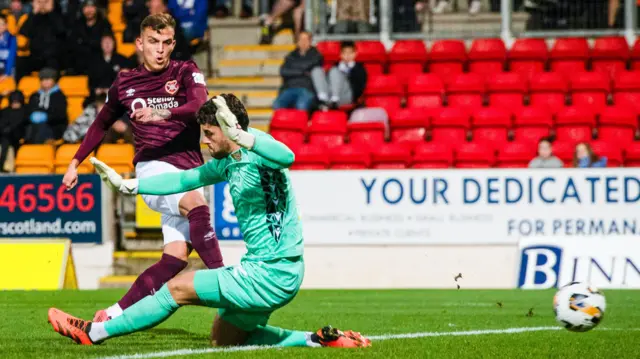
553,282 -> 606,332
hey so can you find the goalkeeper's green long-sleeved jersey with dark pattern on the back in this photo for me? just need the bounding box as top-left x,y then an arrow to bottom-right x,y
138,128 -> 303,261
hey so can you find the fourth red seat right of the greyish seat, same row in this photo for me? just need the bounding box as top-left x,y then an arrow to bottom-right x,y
513,107 -> 553,143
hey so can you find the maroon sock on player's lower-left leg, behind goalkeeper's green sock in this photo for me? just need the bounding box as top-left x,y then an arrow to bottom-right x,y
118,253 -> 187,310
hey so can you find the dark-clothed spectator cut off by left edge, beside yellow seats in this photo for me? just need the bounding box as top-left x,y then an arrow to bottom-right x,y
0,91 -> 26,172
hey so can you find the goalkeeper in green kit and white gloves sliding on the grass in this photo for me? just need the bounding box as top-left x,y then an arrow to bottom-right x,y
48,94 -> 371,347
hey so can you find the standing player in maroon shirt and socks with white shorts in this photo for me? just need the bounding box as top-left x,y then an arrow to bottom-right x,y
62,14 -> 223,321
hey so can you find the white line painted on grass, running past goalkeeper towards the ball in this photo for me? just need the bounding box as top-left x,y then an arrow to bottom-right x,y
101,327 -> 562,359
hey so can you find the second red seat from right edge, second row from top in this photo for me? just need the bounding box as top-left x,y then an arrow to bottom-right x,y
571,72 -> 611,111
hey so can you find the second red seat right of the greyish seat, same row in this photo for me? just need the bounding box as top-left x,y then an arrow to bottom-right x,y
431,108 -> 470,146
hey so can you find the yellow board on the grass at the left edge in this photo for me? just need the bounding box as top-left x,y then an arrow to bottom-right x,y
0,239 -> 78,290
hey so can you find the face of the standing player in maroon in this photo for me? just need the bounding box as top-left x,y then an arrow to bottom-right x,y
136,27 -> 176,72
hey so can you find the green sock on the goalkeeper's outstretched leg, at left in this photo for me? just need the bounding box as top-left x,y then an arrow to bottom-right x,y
89,284 -> 180,342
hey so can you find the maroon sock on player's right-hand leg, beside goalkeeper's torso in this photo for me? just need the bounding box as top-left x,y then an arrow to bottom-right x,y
187,206 -> 224,269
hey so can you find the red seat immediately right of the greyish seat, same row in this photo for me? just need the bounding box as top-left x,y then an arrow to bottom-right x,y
389,108 -> 430,148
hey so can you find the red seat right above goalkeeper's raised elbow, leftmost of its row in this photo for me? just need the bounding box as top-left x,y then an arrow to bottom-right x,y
269,109 -> 308,146
